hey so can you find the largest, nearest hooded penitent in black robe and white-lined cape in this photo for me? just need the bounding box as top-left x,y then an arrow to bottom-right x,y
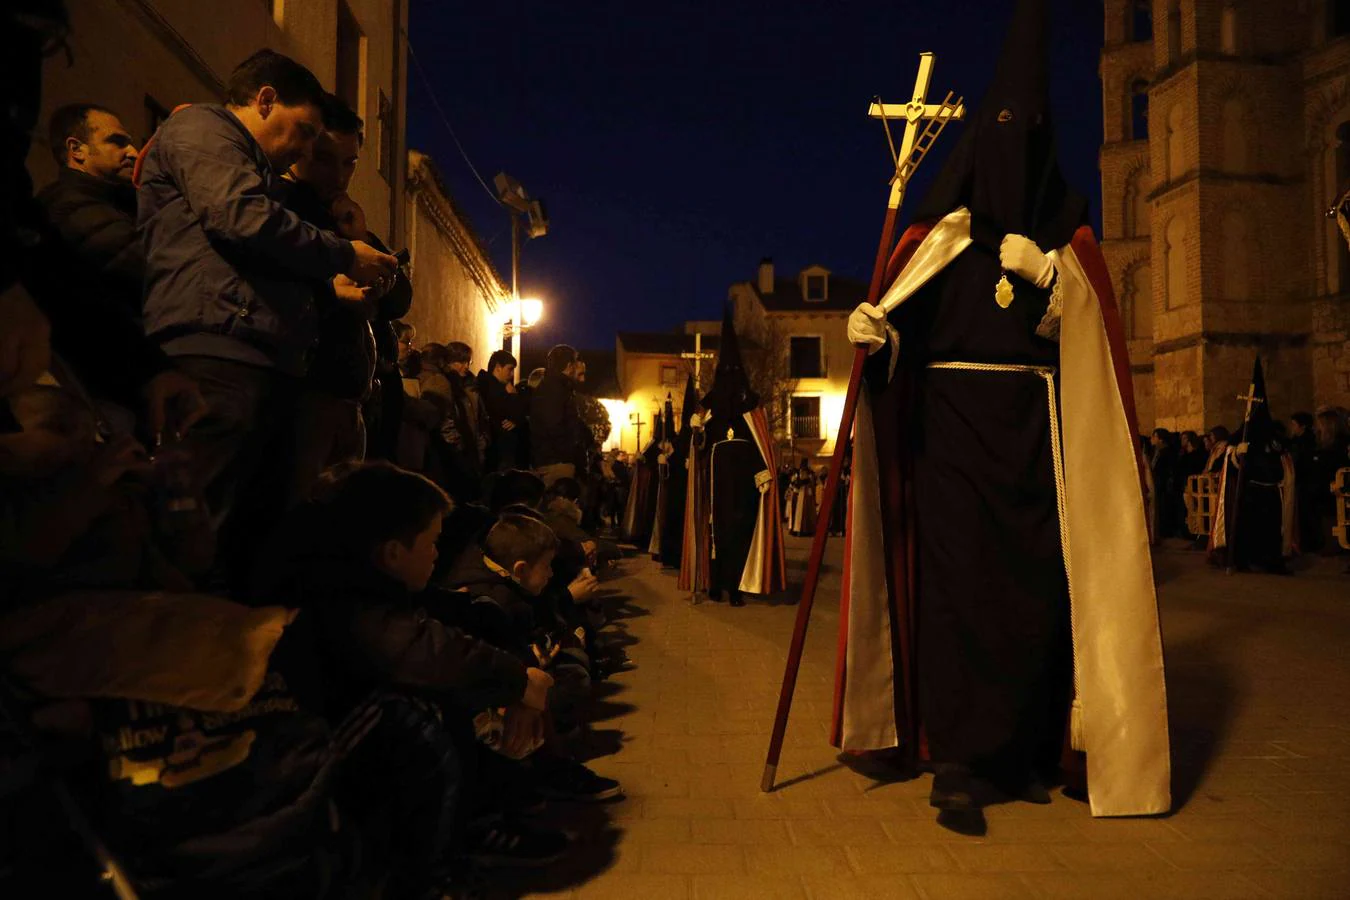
833,0 -> 1170,815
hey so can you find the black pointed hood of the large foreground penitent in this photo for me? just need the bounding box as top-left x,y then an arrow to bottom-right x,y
915,0 -> 1088,254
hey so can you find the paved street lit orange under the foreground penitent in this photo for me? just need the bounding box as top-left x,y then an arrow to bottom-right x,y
510,540 -> 1350,900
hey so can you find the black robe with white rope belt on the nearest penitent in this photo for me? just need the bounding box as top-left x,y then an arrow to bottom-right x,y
879,244 -> 1072,770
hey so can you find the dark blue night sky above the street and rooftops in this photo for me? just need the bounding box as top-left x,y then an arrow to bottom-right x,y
408,0 -> 1102,348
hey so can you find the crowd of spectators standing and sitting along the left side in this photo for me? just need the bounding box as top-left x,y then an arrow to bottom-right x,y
0,22 -> 630,899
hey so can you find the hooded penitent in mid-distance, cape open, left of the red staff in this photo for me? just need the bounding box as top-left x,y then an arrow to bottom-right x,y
702,306 -> 787,596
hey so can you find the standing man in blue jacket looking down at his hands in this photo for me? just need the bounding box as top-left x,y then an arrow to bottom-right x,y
138,50 -> 398,583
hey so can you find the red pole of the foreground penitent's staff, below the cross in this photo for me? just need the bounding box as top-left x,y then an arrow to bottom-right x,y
760,178 -> 905,792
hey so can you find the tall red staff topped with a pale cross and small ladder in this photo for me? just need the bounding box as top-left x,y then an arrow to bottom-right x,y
760,53 -> 965,791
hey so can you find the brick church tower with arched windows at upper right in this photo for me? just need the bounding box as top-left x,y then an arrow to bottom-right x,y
1102,0 -> 1350,430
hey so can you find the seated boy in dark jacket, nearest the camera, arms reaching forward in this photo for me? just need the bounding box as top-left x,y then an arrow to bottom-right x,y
262,461 -> 568,881
